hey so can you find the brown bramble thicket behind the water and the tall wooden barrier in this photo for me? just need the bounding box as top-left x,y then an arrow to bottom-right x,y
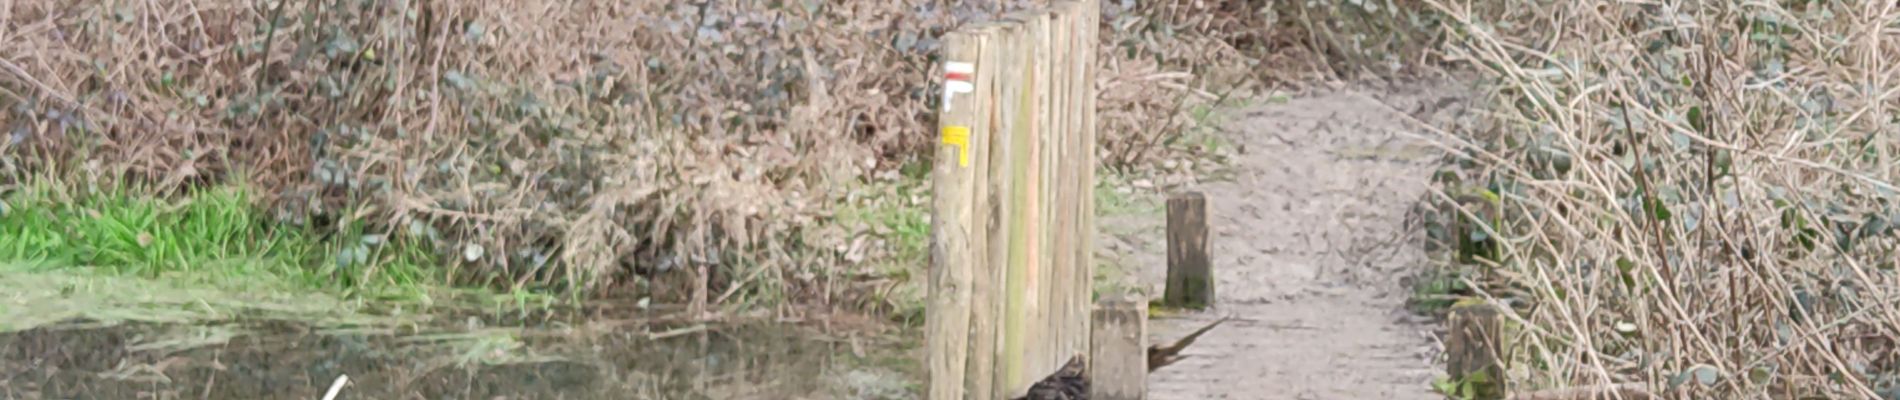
0,0 -> 1436,314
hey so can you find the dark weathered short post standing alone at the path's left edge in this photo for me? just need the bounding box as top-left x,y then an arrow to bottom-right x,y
1163,191 -> 1214,309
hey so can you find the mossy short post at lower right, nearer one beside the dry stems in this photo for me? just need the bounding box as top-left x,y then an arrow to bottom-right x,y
1444,303 -> 1505,400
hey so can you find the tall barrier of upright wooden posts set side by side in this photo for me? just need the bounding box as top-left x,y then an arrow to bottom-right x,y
925,0 -> 1100,400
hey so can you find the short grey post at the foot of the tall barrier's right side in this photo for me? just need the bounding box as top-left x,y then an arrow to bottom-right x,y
1089,298 -> 1148,400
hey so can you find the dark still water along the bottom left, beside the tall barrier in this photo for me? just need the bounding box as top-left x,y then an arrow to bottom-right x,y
0,320 -> 918,398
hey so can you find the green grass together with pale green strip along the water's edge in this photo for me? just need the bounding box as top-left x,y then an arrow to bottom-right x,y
0,184 -> 561,339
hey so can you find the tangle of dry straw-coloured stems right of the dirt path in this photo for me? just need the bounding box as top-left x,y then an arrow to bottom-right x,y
1433,0 -> 1900,398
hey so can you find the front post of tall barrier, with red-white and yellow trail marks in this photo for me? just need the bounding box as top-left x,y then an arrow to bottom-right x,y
925,32 -> 988,398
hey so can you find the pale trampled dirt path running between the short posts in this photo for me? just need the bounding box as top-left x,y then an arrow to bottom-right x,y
1104,83 -> 1467,400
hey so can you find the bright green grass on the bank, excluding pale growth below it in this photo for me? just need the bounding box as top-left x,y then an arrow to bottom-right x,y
0,184 -> 447,300
